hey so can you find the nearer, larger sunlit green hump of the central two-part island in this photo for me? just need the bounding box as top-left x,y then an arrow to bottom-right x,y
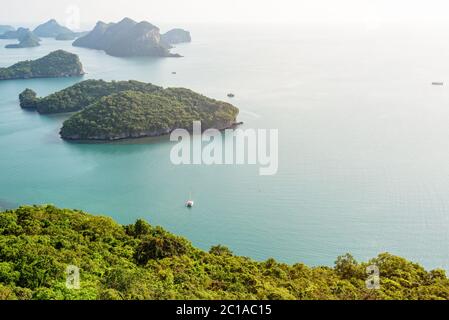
61,88 -> 239,140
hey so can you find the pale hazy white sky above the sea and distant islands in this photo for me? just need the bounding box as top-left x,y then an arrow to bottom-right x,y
0,0 -> 449,27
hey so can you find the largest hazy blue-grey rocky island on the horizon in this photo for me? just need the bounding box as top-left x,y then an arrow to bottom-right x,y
73,18 -> 185,57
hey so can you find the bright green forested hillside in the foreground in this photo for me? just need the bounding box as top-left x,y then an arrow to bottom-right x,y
0,206 -> 449,300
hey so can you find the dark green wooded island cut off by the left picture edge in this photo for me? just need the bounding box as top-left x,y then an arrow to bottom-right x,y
0,50 -> 84,80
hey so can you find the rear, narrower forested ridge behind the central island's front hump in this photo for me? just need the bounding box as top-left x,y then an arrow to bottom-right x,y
20,80 -> 162,114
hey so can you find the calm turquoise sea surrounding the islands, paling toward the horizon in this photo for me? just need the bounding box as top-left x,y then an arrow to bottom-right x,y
0,25 -> 449,269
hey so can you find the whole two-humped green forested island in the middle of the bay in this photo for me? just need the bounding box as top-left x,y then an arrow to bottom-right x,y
19,80 -> 239,141
